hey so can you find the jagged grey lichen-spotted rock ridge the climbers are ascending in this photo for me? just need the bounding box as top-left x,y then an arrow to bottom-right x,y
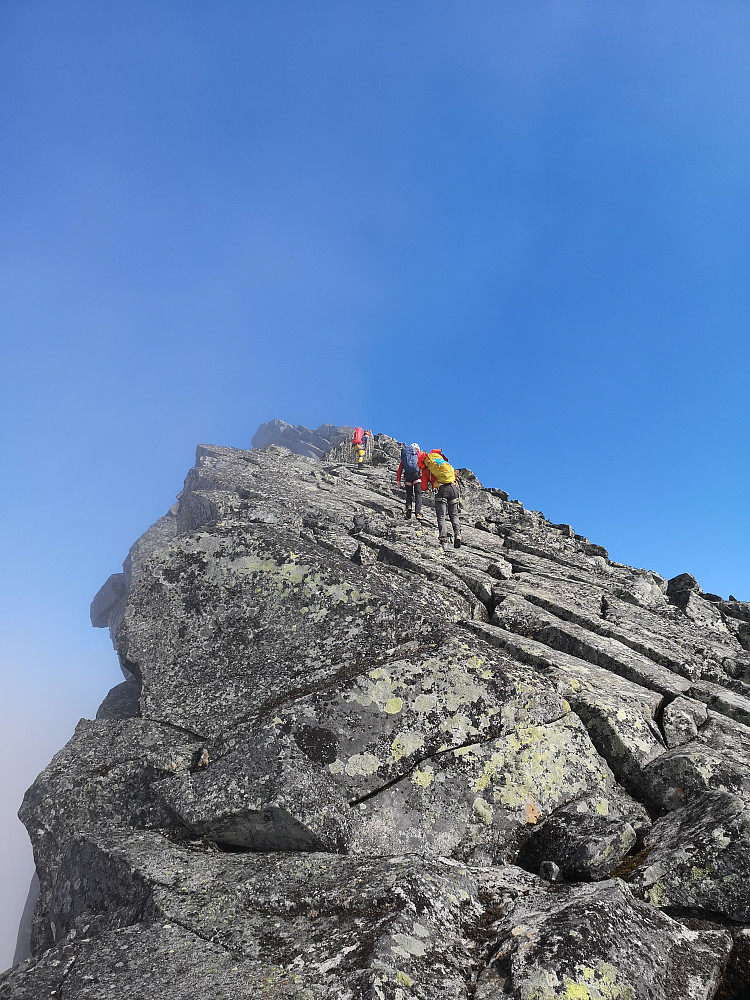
0,421 -> 750,1000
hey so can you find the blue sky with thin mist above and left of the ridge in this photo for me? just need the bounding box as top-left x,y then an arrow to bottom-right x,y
0,0 -> 750,967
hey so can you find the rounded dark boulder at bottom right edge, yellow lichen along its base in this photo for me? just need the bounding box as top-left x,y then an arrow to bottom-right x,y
476,880 -> 732,1000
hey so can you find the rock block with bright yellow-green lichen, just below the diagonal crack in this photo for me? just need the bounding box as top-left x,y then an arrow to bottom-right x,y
354,714 -> 647,864
